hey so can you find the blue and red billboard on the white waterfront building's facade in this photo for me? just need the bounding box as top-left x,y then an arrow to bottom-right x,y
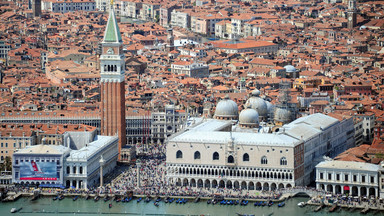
20,161 -> 57,181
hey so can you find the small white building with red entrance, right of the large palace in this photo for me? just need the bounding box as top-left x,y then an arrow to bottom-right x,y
316,160 -> 380,197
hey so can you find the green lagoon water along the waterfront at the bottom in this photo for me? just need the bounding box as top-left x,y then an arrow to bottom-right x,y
0,198 -> 384,216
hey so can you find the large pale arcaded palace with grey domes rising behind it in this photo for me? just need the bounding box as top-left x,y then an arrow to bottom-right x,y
166,94 -> 353,190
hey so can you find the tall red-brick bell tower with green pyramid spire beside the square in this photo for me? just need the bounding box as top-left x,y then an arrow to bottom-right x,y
100,4 -> 126,161
